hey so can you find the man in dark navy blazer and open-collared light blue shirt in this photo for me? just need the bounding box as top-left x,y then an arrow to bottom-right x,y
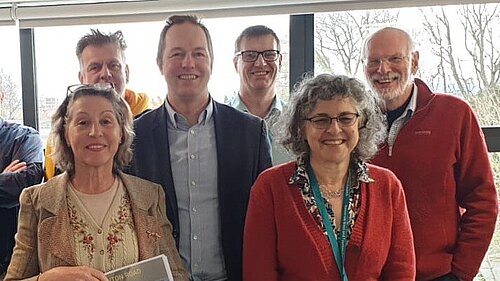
129,16 -> 271,280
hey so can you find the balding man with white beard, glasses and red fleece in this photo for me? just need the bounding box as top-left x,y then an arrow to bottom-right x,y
363,28 -> 498,280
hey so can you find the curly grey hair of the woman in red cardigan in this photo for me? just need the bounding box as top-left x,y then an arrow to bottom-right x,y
280,74 -> 387,160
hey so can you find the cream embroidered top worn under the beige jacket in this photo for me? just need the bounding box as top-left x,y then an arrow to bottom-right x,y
67,180 -> 139,272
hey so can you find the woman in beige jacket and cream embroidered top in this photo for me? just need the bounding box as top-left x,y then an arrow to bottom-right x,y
5,84 -> 188,281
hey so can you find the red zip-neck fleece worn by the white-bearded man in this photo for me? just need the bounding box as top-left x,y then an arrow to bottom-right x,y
373,79 -> 498,280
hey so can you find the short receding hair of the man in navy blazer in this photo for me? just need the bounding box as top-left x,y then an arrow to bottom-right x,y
156,15 -> 214,68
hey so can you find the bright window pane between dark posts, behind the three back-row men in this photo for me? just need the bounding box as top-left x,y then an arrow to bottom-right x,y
35,15 -> 289,142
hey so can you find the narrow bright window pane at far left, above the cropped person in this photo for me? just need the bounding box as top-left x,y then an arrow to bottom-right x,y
0,26 -> 23,123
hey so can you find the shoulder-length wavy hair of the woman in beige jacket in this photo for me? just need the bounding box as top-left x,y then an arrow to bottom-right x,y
49,85 -> 134,175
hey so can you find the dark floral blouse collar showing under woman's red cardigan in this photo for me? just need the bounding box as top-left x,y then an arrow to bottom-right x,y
288,157 -> 373,241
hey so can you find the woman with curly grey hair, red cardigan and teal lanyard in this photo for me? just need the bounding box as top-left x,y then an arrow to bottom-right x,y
243,74 -> 415,281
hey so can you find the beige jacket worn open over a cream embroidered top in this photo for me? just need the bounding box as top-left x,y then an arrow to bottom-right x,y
5,173 -> 188,281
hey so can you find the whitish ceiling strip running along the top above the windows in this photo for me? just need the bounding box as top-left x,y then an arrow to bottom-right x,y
0,0 -> 497,27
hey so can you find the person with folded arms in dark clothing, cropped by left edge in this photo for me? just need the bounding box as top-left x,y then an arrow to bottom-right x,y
0,89 -> 43,280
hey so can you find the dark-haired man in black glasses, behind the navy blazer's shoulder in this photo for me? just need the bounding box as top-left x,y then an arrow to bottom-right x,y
229,25 -> 292,165
